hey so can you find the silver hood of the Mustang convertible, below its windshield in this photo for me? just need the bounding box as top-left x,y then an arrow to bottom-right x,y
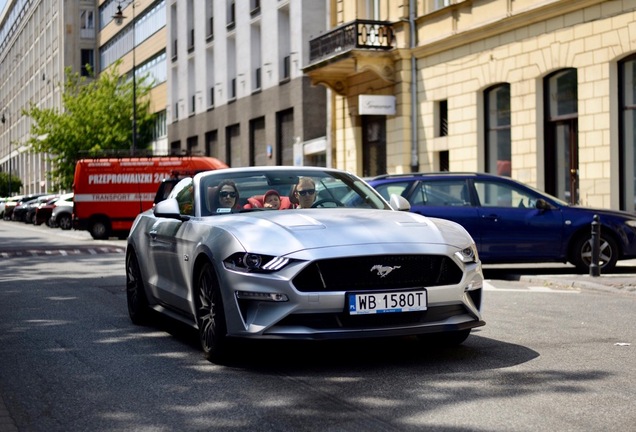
215,209 -> 470,255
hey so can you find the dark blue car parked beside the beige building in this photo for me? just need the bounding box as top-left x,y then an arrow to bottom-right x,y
367,172 -> 636,272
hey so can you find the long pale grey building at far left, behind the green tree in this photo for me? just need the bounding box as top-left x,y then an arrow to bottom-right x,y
0,0 -> 96,194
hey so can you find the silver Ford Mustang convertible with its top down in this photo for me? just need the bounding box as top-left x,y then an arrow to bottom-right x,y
126,167 -> 485,363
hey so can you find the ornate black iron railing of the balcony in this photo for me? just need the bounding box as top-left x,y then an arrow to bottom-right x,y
309,20 -> 393,63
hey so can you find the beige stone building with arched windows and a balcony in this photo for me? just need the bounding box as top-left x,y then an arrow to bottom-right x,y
303,0 -> 636,211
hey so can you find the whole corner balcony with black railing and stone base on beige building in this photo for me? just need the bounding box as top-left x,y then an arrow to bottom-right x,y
303,20 -> 395,94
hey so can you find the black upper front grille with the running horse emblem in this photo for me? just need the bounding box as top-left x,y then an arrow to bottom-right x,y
293,255 -> 462,292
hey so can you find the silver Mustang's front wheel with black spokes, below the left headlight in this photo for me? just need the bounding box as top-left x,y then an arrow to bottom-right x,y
194,262 -> 232,364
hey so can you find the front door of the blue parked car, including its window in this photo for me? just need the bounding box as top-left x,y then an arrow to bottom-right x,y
474,179 -> 563,262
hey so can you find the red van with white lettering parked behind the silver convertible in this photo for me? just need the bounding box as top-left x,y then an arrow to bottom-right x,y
73,156 -> 227,239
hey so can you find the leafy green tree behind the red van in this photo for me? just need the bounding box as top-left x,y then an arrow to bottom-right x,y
23,61 -> 153,189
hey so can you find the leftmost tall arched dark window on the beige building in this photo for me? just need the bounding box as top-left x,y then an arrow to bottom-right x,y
484,84 -> 512,177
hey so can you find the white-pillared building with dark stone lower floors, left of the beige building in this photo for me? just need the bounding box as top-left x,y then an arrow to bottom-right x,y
167,0 -> 331,166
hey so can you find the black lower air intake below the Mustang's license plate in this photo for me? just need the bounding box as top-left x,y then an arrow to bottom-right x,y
277,305 -> 467,330
